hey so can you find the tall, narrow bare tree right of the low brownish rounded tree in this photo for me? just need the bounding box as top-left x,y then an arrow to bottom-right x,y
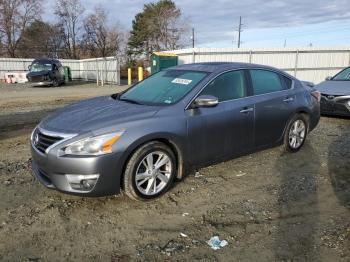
55,0 -> 85,59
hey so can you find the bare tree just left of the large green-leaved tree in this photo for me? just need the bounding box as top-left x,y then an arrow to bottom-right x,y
84,6 -> 123,57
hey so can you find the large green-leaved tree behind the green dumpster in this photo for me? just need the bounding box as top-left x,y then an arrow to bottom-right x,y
128,0 -> 188,57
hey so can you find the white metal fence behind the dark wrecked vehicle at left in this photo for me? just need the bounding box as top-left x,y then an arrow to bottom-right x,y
0,57 -> 120,84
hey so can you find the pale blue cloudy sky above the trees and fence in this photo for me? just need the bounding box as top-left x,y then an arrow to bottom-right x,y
44,0 -> 350,47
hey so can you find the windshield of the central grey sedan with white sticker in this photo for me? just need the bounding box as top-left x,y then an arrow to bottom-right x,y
119,70 -> 207,105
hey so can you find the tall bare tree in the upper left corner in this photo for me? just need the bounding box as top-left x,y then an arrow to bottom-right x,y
0,0 -> 41,57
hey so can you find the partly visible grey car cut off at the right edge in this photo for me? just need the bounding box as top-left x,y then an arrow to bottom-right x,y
315,67 -> 350,116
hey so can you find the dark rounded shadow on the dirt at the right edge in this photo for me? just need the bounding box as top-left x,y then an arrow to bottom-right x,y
328,122 -> 350,210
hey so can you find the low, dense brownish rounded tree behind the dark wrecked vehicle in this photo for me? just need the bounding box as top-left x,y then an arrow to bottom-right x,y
18,20 -> 63,58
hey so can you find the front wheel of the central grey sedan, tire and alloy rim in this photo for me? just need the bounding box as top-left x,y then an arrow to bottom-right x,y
123,141 -> 177,201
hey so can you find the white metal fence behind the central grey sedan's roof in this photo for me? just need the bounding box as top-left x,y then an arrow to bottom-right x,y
170,47 -> 350,83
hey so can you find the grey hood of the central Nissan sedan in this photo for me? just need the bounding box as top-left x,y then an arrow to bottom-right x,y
40,96 -> 159,134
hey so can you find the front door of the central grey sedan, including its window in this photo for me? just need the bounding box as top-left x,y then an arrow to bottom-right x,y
187,70 -> 254,164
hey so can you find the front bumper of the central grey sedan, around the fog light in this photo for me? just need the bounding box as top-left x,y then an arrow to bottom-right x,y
31,141 -> 123,196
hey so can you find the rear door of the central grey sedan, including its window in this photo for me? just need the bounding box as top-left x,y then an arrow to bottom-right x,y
249,69 -> 296,148
